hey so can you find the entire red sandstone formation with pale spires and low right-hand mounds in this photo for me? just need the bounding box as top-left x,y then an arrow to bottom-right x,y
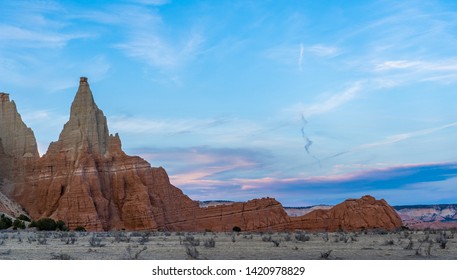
0,77 -> 402,231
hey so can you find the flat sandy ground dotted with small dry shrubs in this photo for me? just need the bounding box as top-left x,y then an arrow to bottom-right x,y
0,230 -> 457,260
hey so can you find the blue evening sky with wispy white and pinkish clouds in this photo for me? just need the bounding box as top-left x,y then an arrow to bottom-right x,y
0,0 -> 457,206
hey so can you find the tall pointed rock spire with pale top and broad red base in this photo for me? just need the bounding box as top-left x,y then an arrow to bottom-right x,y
14,78 -> 197,230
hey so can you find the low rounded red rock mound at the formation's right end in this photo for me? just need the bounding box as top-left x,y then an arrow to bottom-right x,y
289,195 -> 403,231
